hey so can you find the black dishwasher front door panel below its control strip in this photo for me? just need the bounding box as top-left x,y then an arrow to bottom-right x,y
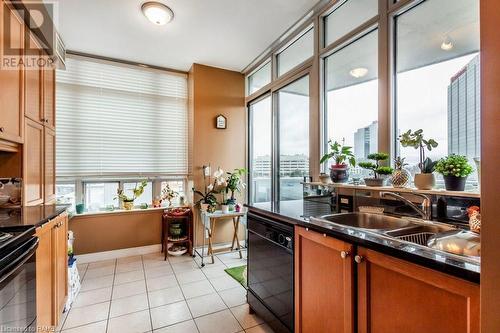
248,229 -> 294,331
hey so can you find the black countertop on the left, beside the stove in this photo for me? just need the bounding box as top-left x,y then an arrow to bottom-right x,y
0,205 -> 69,229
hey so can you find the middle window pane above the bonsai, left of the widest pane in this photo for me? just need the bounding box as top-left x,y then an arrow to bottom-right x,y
324,30 -> 378,173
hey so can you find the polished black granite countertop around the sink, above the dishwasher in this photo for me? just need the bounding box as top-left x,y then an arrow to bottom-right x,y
248,200 -> 481,283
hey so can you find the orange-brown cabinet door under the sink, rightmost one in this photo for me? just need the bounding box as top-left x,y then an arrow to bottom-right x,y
356,248 -> 479,333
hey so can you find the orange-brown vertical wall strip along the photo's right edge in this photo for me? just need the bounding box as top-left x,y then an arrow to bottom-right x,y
480,0 -> 500,333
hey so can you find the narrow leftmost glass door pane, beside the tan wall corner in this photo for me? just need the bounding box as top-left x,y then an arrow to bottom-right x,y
249,96 -> 272,203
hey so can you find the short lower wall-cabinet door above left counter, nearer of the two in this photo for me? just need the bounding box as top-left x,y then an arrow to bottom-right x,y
23,118 -> 44,206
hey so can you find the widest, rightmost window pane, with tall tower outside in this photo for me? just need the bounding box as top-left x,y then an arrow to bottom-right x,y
395,0 -> 480,181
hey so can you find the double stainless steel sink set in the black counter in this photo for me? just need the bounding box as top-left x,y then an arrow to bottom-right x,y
311,213 -> 481,259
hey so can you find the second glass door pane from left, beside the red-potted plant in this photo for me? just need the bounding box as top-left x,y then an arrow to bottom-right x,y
275,75 -> 309,201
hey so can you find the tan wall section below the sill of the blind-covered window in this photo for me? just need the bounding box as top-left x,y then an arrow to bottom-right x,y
69,210 -> 163,254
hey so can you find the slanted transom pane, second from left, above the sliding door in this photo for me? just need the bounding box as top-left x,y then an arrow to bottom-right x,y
276,28 -> 314,76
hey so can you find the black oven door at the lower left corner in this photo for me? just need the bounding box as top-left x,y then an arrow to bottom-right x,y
0,237 -> 38,332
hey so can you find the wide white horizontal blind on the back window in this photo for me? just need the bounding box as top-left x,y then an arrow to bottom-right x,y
56,57 -> 188,177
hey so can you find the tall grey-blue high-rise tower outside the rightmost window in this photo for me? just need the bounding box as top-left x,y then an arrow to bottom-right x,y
448,55 -> 481,157
